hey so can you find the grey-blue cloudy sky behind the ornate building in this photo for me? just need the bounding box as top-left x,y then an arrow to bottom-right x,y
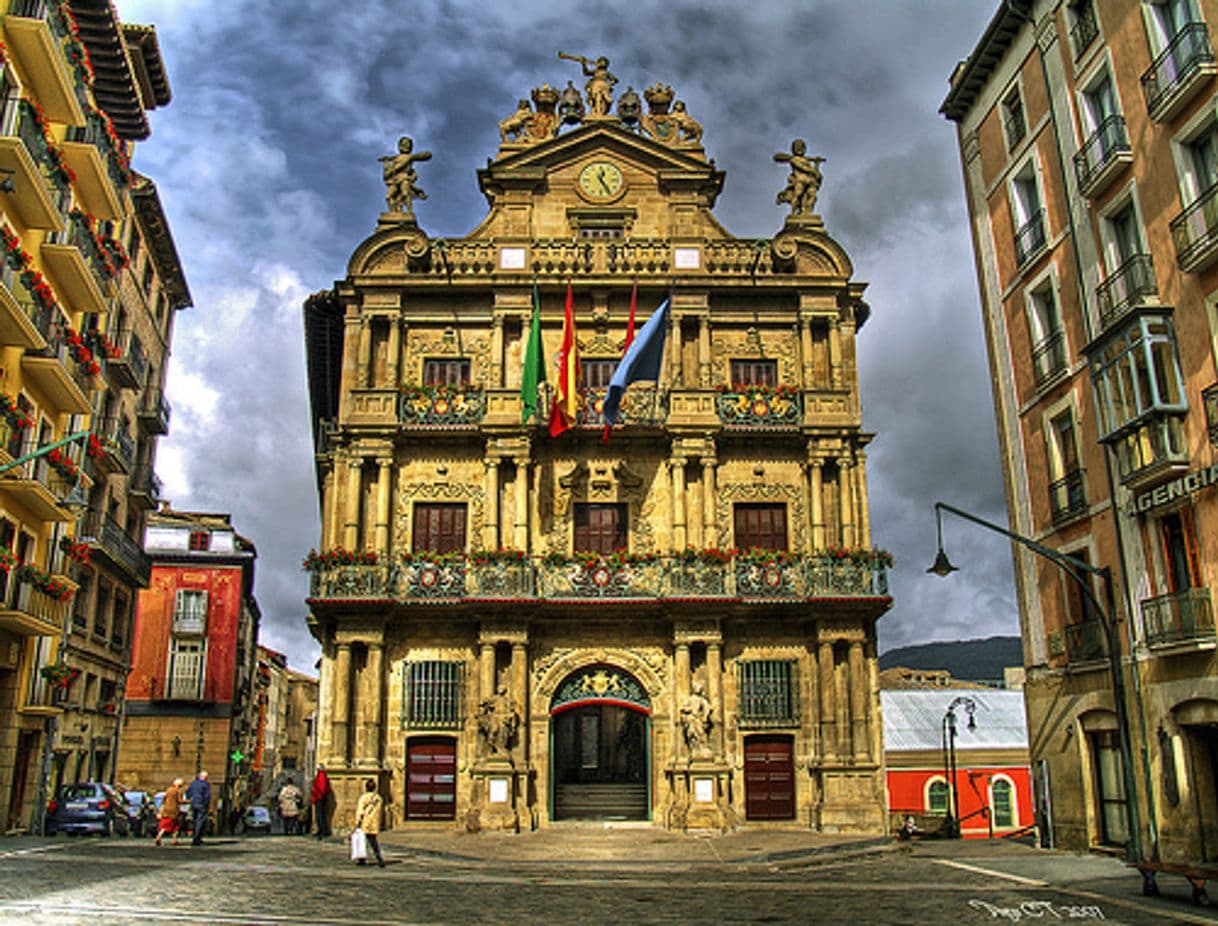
114,0 -> 1018,669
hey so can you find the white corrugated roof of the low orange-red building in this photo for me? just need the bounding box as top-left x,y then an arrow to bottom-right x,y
879,688 -> 1028,752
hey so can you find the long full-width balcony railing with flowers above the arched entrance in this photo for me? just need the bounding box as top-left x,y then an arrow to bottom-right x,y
309,554 -> 888,603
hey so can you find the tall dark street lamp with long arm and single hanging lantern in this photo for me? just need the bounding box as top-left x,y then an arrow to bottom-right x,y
927,502 -> 1141,861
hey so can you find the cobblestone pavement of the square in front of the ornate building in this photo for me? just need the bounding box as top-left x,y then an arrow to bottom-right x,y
0,829 -> 1218,926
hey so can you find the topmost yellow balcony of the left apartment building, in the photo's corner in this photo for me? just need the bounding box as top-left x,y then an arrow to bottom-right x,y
4,0 -> 84,125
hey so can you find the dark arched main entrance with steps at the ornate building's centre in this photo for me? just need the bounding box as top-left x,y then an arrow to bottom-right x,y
549,665 -> 652,820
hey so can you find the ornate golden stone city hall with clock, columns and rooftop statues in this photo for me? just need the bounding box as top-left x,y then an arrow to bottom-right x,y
305,65 -> 892,832
